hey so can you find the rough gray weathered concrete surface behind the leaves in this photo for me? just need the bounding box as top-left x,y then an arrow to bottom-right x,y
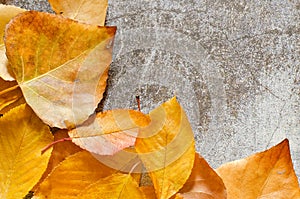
2,0 -> 300,181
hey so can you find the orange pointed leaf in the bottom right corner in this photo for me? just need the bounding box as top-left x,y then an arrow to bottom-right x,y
217,139 -> 300,199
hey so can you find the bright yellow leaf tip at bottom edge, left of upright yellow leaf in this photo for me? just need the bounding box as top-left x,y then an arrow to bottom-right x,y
78,173 -> 144,199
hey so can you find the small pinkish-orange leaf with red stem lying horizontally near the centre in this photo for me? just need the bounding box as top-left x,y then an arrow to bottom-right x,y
69,109 -> 150,155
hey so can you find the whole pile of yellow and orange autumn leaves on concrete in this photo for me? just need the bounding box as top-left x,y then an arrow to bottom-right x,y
0,0 -> 300,199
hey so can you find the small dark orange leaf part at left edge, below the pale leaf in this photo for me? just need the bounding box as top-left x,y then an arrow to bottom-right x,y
0,78 -> 25,114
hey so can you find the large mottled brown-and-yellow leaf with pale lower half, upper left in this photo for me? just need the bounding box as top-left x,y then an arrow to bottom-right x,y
5,11 -> 116,128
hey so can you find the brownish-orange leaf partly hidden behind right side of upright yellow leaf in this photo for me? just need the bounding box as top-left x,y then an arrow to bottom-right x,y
177,153 -> 226,199
